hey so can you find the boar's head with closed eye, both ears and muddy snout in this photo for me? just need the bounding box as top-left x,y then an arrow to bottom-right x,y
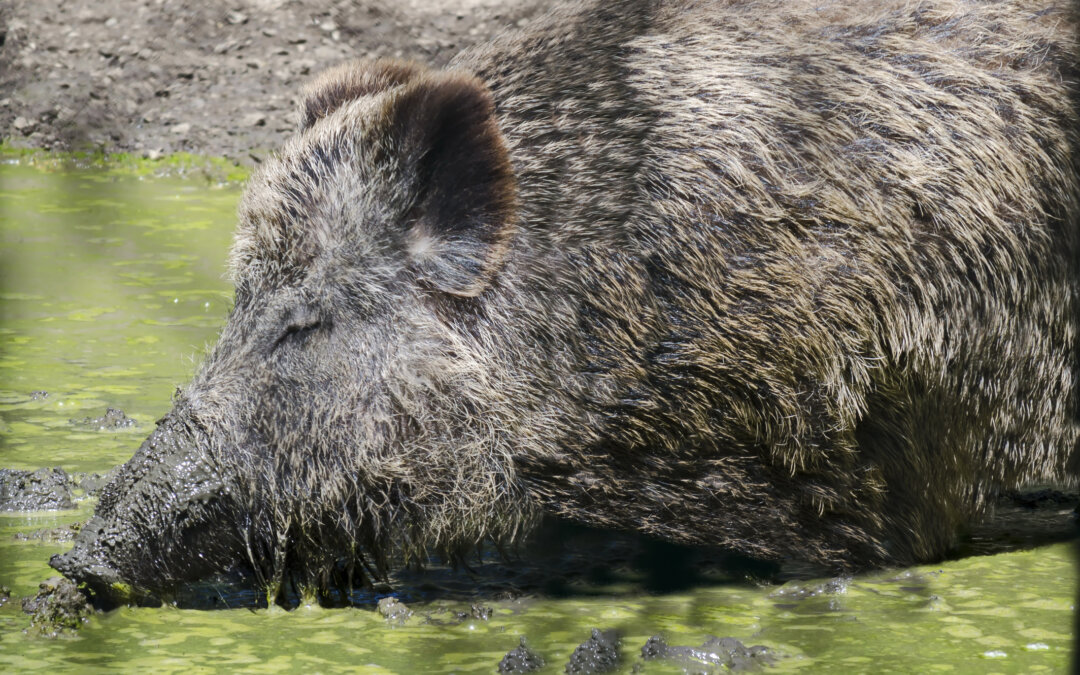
52,62 -> 530,596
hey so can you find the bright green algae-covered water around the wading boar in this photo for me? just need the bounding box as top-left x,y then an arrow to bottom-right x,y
0,156 -> 1078,674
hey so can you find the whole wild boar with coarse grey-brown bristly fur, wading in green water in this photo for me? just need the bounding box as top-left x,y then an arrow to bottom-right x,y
54,0 -> 1080,604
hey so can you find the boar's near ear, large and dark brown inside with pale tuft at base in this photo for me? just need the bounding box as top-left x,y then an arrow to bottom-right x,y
387,72 -> 515,297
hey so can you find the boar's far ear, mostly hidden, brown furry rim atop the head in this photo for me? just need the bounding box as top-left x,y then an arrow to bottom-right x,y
300,58 -> 427,131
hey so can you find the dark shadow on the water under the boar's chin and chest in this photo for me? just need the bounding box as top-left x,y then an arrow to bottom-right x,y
172,518 -> 785,609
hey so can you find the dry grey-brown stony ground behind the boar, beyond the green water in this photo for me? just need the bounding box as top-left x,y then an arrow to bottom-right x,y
0,0 -> 548,165
